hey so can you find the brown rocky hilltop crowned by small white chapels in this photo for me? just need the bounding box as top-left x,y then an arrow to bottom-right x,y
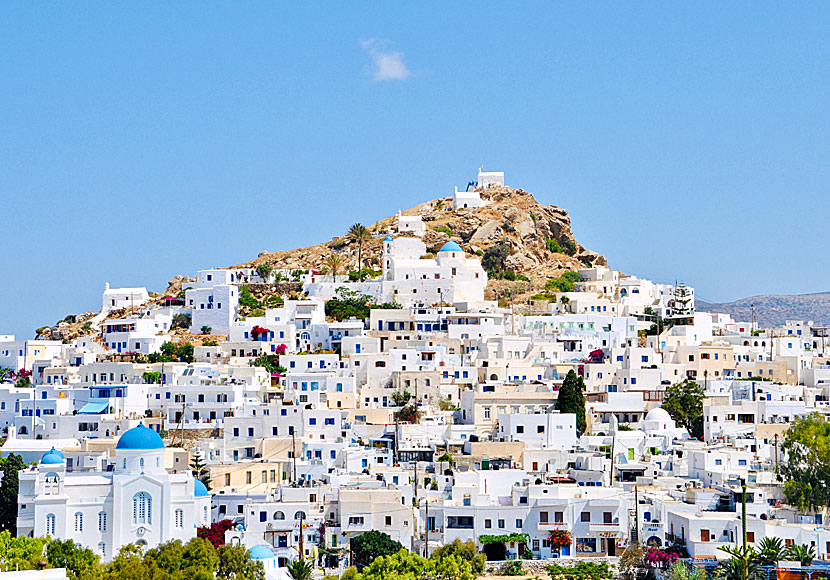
240,187 -> 606,302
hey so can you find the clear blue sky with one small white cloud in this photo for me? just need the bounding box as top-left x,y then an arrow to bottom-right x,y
0,2 -> 830,337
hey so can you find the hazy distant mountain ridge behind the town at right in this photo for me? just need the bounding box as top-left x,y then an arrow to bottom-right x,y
695,292 -> 830,328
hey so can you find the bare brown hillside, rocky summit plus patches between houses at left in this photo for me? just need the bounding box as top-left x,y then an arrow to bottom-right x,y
36,186 -> 606,343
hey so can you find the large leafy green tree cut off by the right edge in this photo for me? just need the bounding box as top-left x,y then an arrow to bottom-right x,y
778,413 -> 830,510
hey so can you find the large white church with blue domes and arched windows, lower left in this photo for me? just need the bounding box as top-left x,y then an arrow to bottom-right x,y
17,424 -> 210,560
